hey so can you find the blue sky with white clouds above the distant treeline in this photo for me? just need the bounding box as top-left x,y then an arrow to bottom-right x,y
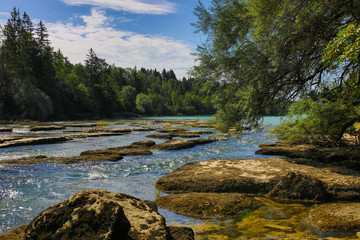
0,0 -> 205,78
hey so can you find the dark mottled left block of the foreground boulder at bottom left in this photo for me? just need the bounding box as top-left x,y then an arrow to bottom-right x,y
24,191 -> 131,240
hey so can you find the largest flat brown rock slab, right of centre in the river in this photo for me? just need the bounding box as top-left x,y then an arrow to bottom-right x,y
156,158 -> 360,201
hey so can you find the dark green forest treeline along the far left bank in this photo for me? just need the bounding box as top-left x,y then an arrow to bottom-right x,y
0,8 -> 215,120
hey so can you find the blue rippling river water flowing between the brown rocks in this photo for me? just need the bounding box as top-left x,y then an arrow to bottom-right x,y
0,117 -> 275,234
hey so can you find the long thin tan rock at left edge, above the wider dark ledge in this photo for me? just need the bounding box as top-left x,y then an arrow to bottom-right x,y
0,136 -> 72,148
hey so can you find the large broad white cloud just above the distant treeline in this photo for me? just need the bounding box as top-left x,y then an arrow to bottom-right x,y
46,9 -> 194,78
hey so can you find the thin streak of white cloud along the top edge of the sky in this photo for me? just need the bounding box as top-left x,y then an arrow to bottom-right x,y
62,0 -> 176,14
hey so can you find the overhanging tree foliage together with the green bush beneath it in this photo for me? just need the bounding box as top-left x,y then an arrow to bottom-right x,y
193,0 -> 360,141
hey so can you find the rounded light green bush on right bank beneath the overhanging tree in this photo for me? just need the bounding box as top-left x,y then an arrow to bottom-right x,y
272,99 -> 360,144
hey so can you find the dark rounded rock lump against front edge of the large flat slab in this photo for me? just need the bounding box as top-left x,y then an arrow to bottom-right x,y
266,172 -> 332,201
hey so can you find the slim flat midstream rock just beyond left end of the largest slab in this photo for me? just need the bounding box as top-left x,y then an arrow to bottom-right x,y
154,138 -> 215,150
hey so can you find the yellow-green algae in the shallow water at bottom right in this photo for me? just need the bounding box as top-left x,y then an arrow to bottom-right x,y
187,198 -> 358,240
